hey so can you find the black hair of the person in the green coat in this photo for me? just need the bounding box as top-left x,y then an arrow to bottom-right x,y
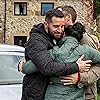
64,22 -> 86,41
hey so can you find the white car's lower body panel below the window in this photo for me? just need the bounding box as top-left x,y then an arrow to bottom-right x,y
0,84 -> 22,100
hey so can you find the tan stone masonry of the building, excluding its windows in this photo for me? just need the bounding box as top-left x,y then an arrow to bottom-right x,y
0,0 -> 94,44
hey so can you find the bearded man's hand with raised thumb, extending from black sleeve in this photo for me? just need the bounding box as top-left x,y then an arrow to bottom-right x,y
76,55 -> 92,72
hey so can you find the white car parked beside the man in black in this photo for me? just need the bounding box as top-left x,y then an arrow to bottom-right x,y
0,44 -> 25,100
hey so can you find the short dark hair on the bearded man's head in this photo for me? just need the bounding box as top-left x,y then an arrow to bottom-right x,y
45,9 -> 64,22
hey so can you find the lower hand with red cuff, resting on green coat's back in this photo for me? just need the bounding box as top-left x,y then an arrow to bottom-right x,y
60,73 -> 79,85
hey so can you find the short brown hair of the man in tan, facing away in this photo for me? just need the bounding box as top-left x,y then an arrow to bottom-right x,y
56,5 -> 77,23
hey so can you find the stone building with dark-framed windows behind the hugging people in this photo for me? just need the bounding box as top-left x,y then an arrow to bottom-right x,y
0,0 -> 93,46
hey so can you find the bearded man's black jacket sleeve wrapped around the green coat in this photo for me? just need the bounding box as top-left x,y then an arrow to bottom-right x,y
25,36 -> 79,76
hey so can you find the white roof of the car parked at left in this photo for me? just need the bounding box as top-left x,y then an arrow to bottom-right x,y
0,44 -> 25,52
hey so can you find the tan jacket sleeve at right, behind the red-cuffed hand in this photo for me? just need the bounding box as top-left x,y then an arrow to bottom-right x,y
78,65 -> 100,87
